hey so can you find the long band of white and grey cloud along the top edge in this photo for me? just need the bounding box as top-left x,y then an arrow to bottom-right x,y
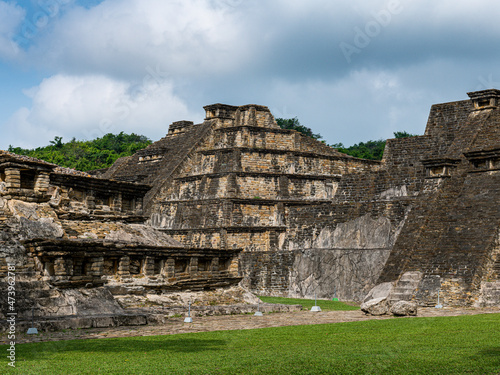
13,0 -> 500,80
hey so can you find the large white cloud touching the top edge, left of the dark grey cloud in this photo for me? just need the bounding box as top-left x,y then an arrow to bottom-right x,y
29,0 -> 247,78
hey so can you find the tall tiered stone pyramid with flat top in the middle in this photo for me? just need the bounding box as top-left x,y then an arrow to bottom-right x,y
97,104 -> 384,299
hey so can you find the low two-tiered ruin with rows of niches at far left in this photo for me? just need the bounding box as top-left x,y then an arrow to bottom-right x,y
0,151 -> 241,317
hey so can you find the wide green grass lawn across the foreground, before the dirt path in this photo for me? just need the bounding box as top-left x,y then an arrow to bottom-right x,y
0,314 -> 500,375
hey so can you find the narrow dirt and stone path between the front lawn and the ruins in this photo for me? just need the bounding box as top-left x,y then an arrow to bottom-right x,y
0,308 -> 500,344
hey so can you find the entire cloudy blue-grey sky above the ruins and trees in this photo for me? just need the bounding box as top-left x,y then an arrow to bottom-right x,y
0,0 -> 500,149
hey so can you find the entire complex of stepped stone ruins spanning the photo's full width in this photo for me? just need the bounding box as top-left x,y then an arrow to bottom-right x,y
0,90 -> 500,320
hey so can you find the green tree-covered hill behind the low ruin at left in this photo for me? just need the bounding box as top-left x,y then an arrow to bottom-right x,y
9,132 -> 151,171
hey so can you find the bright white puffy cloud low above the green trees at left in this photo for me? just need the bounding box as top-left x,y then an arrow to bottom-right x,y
3,75 -> 192,147
